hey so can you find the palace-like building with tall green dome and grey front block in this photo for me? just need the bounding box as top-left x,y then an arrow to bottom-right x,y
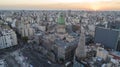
53,13 -> 78,63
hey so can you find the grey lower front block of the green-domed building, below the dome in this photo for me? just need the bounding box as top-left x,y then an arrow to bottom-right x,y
54,39 -> 78,63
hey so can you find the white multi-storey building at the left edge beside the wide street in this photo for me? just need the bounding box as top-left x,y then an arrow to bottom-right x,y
0,29 -> 17,49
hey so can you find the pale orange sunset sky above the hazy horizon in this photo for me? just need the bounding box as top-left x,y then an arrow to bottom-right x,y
0,0 -> 120,10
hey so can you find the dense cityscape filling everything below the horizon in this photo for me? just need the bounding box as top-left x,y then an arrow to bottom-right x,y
0,10 -> 120,67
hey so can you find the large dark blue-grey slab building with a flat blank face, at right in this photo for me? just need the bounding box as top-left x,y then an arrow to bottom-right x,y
95,27 -> 120,50
